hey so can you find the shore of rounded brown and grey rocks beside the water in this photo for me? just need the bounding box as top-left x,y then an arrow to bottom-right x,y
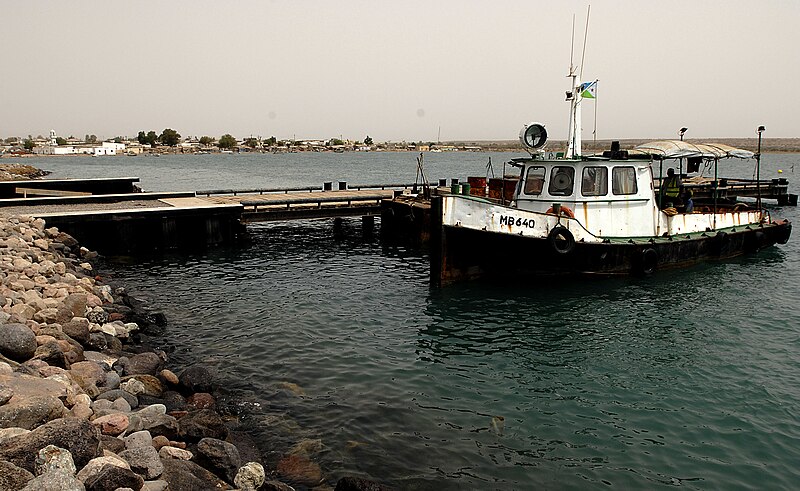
0,216 -> 386,491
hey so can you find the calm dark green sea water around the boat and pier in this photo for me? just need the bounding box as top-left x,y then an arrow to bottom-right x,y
12,153 -> 800,490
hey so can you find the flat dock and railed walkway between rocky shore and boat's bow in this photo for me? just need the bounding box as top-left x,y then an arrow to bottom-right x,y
0,182 -> 412,254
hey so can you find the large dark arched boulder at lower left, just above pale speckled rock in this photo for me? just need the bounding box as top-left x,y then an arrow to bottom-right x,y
0,418 -> 102,472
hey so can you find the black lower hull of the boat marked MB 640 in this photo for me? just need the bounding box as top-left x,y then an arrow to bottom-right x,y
431,201 -> 792,285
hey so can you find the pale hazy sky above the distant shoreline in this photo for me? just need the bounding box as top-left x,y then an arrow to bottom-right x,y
0,0 -> 800,141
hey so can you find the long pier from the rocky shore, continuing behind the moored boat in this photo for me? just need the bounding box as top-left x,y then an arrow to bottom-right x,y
0,177 -> 797,254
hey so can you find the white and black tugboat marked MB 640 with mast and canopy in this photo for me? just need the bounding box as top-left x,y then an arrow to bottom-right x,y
430,70 -> 792,285
